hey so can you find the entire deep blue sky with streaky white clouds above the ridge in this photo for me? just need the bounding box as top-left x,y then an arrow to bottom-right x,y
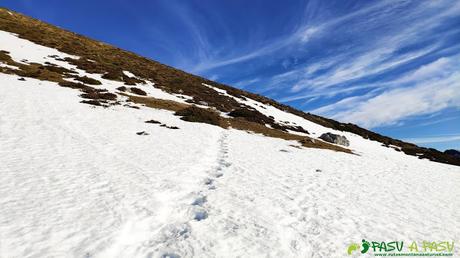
1,0 -> 460,149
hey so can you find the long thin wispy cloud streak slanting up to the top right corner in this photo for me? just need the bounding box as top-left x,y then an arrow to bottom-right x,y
273,0 -> 460,99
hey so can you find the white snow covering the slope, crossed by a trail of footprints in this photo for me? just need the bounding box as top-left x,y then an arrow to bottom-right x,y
0,29 -> 460,257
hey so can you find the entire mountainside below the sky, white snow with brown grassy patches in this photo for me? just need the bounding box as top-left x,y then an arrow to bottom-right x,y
0,9 -> 460,257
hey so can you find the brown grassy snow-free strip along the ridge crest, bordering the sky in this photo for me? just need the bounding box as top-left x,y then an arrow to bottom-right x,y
0,8 -> 460,165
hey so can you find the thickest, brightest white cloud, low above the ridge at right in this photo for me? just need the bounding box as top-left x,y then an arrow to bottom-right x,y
330,57 -> 460,128
